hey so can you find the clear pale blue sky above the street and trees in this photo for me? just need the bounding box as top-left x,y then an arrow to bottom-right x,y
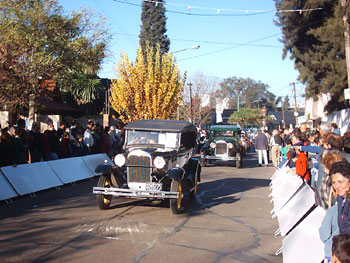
58,0 -> 304,104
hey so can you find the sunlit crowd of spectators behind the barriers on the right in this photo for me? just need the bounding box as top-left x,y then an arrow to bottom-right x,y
255,122 -> 350,262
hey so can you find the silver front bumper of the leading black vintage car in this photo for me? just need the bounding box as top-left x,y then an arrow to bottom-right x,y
92,187 -> 179,199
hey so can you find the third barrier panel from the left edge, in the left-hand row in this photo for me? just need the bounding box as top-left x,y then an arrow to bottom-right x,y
48,157 -> 95,184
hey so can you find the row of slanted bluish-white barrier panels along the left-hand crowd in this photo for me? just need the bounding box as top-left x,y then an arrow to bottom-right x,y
0,154 -> 112,202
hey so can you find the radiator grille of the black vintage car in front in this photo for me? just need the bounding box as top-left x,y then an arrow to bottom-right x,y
127,156 -> 152,183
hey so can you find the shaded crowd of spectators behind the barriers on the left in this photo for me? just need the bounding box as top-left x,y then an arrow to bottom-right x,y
0,119 -> 122,167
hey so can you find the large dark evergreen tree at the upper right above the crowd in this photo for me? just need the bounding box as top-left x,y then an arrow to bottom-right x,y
276,0 -> 349,112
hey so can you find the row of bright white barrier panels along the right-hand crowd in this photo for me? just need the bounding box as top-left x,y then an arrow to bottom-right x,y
270,167 -> 326,263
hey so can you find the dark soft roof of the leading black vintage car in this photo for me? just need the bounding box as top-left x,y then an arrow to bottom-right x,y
124,120 -> 197,132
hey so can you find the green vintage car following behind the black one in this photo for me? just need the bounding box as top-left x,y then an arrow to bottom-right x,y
201,125 -> 244,168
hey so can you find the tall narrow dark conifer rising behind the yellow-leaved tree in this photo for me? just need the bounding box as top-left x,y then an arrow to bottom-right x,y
139,0 -> 170,55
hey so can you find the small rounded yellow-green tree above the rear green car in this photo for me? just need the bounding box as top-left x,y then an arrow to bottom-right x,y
228,108 -> 265,127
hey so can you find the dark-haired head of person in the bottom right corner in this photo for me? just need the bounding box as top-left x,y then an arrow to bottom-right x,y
331,235 -> 350,263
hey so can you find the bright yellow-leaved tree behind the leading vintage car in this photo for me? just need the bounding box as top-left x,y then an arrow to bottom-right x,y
111,45 -> 186,123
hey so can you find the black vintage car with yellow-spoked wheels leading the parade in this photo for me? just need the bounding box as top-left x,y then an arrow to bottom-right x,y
93,120 -> 201,214
